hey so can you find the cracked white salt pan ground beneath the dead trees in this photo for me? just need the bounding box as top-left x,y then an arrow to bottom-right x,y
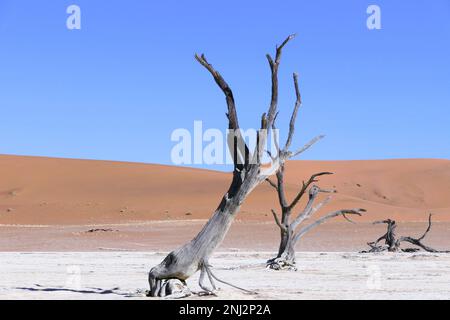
0,252 -> 450,300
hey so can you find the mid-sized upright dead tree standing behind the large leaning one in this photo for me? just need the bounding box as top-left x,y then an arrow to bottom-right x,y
266,168 -> 365,270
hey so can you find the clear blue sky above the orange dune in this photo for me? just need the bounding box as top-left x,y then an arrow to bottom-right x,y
0,0 -> 450,169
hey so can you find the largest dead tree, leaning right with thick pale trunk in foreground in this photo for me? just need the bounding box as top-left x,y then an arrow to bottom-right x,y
148,35 -> 324,297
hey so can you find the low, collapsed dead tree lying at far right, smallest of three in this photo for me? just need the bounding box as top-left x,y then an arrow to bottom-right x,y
362,213 -> 449,253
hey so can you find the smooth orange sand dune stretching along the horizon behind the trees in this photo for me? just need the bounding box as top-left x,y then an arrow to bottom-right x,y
0,155 -> 450,225
